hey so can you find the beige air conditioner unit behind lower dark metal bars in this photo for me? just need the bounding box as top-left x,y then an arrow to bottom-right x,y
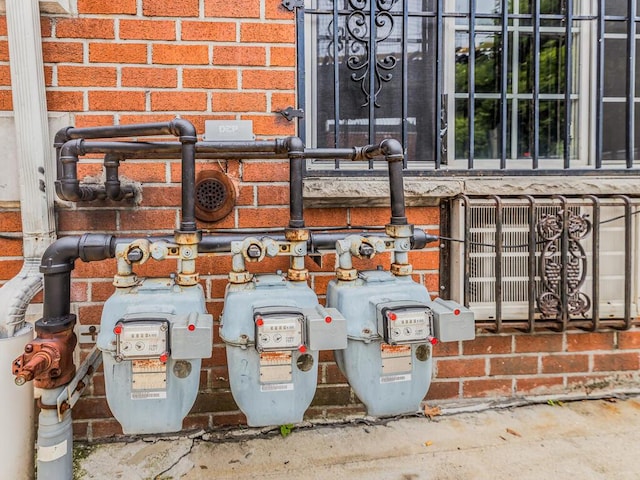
444,196 -> 640,330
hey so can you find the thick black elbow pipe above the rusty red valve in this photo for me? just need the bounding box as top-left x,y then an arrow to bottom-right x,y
40,233 -> 115,324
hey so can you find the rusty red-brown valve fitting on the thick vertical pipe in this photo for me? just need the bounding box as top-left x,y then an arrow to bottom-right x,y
12,315 -> 78,389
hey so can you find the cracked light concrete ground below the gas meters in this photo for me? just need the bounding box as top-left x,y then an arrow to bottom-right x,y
75,397 -> 640,480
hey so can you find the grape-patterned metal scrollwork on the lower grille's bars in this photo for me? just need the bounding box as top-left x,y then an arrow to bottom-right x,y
537,210 -> 591,318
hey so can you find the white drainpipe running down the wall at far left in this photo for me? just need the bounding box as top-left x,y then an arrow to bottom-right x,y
0,0 -> 56,479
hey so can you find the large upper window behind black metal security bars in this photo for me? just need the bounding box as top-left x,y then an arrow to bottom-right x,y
298,0 -> 640,175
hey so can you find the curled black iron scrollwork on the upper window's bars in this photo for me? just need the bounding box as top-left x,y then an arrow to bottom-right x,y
330,0 -> 398,107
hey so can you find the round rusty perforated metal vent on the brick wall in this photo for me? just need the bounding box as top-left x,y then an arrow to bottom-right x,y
196,170 -> 236,222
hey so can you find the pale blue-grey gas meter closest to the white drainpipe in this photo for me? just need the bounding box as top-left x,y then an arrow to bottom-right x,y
98,278 -> 213,434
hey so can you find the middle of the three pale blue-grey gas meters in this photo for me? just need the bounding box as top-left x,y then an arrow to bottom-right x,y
220,275 -> 347,427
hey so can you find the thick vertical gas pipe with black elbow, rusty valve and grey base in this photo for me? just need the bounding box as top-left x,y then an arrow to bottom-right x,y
13,234 -> 115,480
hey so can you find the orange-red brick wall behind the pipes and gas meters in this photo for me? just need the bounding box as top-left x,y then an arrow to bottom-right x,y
0,0 -> 640,439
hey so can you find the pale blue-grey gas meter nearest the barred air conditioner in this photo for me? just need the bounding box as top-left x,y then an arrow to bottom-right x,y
327,270 -> 474,416
